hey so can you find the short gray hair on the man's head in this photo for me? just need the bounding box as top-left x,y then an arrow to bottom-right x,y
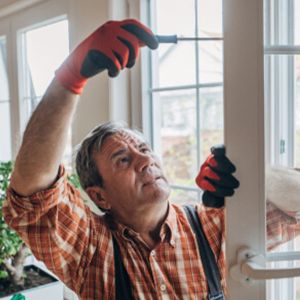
75,122 -> 145,190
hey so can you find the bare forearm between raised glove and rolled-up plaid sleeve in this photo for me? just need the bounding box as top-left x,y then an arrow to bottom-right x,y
11,79 -> 78,196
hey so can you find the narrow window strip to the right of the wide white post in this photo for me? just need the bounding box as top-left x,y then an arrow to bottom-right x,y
265,0 -> 300,299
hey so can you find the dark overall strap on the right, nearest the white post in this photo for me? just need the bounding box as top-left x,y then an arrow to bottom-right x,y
183,205 -> 225,300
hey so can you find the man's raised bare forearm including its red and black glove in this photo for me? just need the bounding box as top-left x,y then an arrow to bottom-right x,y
11,20 -> 158,196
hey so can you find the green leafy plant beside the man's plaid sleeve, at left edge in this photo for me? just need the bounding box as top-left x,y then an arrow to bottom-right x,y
0,161 -> 28,286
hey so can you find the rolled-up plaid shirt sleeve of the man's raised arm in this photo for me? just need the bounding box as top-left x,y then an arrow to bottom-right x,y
3,166 -> 108,292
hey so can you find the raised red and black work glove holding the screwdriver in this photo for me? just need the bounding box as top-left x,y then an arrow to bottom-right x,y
55,19 -> 158,94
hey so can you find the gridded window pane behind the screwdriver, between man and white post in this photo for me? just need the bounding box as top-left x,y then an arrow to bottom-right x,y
149,0 -> 223,203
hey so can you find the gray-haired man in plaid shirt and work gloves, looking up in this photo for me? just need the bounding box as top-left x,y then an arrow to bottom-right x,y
3,20 -> 298,299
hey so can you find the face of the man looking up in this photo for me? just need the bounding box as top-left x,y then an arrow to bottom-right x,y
94,131 -> 170,216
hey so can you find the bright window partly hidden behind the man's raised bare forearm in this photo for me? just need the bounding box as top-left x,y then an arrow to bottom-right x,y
19,19 -> 72,166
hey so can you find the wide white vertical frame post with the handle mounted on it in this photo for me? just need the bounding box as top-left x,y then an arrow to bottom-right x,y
223,0 -> 266,300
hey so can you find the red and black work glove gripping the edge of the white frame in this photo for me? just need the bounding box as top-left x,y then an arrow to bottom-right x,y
196,145 -> 240,208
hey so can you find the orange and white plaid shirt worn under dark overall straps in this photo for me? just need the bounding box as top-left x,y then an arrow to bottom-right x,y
3,167 -> 300,299
